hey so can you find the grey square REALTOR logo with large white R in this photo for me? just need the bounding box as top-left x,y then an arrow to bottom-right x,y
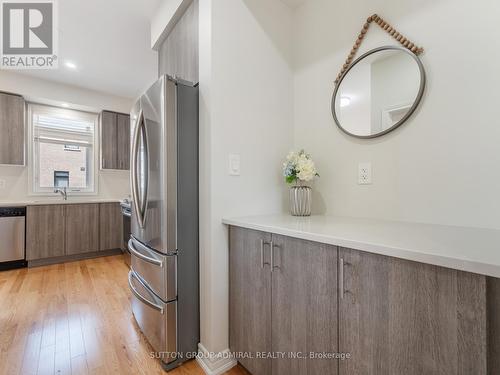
0,0 -> 57,69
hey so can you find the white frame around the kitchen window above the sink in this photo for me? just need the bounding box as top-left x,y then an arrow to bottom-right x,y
26,102 -> 100,196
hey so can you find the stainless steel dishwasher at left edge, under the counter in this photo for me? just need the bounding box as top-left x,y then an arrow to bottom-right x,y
0,207 -> 27,270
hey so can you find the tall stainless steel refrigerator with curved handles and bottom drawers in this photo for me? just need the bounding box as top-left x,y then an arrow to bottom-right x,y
128,76 -> 200,370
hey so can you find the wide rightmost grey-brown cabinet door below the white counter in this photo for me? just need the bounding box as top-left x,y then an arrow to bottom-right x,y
339,249 -> 486,375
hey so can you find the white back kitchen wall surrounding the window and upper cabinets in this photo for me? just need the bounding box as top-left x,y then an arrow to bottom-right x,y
0,71 -> 132,201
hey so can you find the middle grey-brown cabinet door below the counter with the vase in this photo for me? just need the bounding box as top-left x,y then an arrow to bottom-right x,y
272,235 -> 338,375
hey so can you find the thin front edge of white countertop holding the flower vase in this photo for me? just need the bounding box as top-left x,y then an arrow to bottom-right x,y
222,218 -> 500,278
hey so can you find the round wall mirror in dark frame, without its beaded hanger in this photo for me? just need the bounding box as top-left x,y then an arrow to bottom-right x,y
332,46 -> 425,138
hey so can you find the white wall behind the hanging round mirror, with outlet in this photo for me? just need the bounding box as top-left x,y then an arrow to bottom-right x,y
293,0 -> 500,228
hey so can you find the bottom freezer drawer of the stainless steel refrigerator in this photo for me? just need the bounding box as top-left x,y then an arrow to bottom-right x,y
128,270 -> 177,363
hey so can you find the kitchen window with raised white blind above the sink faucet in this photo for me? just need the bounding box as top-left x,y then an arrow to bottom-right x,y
28,104 -> 97,194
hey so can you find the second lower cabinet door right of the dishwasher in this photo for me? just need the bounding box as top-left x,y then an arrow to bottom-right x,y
65,204 -> 99,255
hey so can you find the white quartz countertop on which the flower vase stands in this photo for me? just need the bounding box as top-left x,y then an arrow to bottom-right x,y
223,215 -> 500,278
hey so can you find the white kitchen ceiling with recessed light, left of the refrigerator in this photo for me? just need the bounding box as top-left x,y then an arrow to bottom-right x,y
20,0 -> 161,98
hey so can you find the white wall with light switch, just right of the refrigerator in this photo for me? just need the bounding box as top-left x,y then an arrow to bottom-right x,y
200,0 -> 293,358
